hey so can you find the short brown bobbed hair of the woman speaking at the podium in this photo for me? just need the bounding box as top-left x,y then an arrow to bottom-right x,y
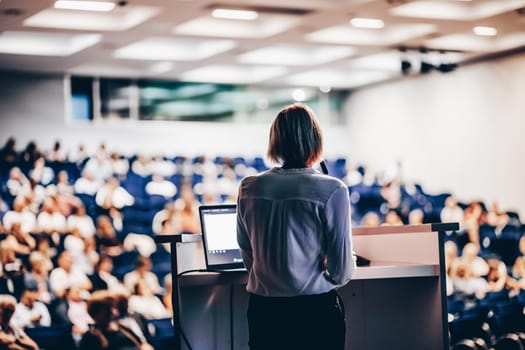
268,103 -> 323,166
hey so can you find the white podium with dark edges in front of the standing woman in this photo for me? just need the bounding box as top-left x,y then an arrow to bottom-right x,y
155,223 -> 459,350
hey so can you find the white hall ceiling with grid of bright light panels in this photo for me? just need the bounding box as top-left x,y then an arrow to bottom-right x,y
0,0 -> 525,88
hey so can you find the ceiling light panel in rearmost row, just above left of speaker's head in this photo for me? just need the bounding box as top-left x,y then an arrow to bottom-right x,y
181,65 -> 287,84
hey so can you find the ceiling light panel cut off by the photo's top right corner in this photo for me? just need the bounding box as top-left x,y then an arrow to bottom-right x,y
390,0 -> 525,21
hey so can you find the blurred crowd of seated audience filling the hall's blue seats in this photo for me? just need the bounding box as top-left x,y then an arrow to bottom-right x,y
0,138 -> 525,349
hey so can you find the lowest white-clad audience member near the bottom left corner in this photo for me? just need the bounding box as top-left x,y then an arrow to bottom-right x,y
11,288 -> 51,328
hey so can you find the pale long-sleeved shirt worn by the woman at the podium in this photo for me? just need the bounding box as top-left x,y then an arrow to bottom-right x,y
237,168 -> 355,296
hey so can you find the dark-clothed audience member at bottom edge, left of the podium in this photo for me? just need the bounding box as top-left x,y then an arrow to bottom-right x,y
79,291 -> 143,350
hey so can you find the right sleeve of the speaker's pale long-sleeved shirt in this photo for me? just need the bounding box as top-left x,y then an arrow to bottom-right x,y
326,186 -> 355,286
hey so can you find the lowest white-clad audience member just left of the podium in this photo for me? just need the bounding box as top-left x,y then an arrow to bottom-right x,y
129,280 -> 170,319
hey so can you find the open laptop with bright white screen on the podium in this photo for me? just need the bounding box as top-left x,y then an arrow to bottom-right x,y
199,204 -> 245,270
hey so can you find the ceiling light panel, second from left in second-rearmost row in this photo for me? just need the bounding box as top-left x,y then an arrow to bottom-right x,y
114,37 -> 236,61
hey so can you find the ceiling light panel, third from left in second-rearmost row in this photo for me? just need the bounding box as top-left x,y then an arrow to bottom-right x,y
237,44 -> 355,66
